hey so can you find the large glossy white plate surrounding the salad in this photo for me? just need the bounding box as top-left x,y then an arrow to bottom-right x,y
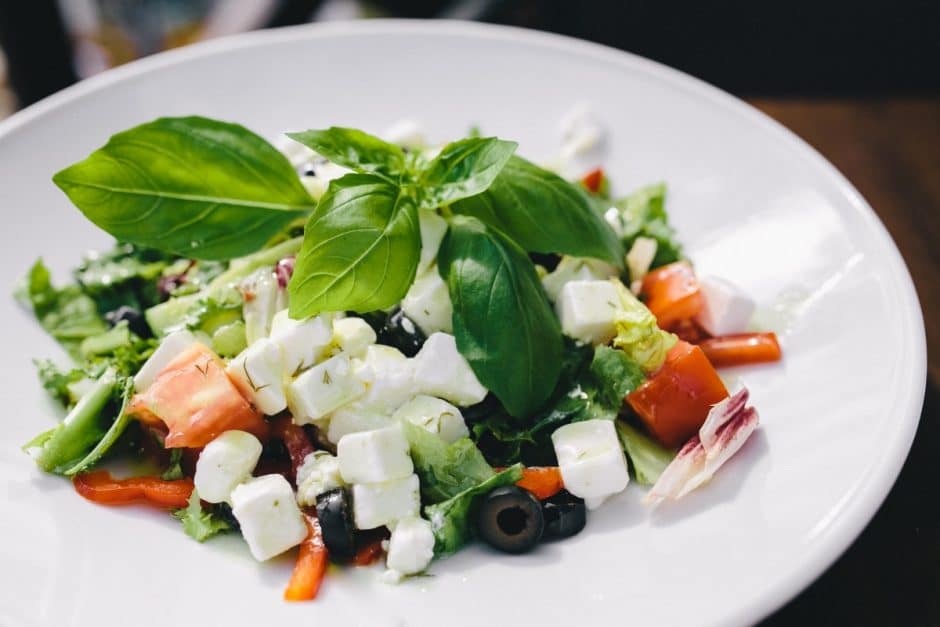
0,22 -> 926,627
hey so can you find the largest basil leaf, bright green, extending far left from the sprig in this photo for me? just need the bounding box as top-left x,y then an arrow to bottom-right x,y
52,117 -> 315,259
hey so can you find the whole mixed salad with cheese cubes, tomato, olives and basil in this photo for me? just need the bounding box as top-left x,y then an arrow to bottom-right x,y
18,117 -> 781,600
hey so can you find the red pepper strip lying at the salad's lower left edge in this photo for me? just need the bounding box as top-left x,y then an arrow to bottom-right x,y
72,470 -> 193,509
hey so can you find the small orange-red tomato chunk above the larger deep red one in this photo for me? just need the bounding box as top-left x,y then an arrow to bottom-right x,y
640,261 -> 704,329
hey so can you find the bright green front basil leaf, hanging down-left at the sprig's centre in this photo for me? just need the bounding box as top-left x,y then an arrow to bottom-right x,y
288,174 -> 421,318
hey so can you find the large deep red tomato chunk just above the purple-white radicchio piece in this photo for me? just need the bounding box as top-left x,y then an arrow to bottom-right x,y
627,341 -> 728,447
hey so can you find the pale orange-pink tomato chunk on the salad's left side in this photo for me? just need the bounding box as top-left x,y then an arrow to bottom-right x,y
128,343 -> 268,448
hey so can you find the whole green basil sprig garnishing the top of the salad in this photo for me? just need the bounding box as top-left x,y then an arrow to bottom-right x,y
54,117 -> 623,418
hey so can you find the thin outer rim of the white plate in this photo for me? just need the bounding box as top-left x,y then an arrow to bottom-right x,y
0,19 -> 927,623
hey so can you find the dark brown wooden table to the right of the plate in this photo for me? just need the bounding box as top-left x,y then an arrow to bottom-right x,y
751,98 -> 940,626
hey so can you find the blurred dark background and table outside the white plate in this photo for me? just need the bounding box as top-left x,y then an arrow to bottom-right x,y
0,0 -> 940,626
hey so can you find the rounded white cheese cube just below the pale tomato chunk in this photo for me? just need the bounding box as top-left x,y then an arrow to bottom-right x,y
193,430 -> 261,503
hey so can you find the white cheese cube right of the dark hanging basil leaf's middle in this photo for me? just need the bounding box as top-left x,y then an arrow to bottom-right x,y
555,281 -> 620,344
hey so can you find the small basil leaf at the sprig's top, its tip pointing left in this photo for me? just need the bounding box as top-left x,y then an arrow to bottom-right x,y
287,126 -> 405,175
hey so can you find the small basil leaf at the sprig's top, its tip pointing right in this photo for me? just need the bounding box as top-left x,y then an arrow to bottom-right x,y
420,137 -> 518,209
